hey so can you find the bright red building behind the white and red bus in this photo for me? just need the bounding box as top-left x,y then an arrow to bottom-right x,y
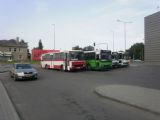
32,48 -> 59,61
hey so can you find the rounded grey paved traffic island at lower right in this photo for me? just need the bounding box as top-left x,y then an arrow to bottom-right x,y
95,85 -> 160,114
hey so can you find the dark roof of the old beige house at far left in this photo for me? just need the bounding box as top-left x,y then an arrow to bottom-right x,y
0,39 -> 28,47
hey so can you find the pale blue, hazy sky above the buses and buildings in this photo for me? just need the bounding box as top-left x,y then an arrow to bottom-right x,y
0,0 -> 160,51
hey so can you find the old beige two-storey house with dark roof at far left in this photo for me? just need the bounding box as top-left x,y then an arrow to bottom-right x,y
0,38 -> 28,61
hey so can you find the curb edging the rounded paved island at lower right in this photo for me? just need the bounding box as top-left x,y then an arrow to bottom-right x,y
94,88 -> 160,115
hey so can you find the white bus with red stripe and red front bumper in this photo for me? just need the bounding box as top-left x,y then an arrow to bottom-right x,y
41,50 -> 86,71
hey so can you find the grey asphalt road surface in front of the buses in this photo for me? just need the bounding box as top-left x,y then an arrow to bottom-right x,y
0,65 -> 160,120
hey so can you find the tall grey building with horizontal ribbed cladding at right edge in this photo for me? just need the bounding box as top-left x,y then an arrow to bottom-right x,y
145,12 -> 160,64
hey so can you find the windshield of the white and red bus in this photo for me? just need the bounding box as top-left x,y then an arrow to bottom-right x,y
69,51 -> 84,60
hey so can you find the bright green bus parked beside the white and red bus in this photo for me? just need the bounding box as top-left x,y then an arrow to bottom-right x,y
84,50 -> 112,70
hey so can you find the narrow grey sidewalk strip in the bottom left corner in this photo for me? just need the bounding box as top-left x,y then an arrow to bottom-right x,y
0,80 -> 20,120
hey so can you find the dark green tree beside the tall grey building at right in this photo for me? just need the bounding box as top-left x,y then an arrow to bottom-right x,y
128,43 -> 144,60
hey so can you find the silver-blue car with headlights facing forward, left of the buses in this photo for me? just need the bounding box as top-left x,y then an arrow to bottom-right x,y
10,63 -> 38,81
